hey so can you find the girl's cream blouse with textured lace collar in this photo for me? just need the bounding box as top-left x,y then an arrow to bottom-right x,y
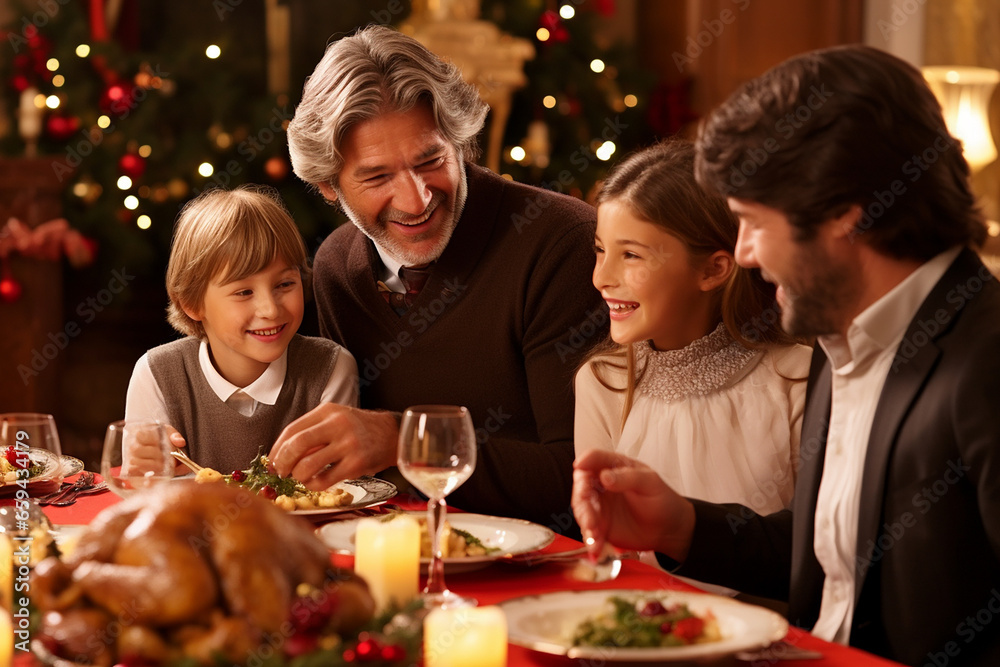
574,325 -> 812,514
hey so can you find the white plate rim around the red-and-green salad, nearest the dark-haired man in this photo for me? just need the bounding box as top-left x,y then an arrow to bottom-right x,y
499,590 -> 788,662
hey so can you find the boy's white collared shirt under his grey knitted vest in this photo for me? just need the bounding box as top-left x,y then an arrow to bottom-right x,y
125,340 -> 358,423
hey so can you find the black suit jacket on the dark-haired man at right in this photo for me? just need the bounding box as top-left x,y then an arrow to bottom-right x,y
679,250 -> 1000,667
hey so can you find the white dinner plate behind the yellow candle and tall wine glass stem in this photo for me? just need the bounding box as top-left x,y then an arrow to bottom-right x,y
317,512 -> 555,572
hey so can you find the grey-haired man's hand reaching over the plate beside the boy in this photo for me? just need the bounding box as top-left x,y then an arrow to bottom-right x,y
268,403 -> 399,491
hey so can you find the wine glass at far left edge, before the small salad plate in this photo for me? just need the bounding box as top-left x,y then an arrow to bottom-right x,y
0,412 -> 63,496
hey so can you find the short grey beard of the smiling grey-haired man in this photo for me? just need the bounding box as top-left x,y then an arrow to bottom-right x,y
335,168 -> 468,266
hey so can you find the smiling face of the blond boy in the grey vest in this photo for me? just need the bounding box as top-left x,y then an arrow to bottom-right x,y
185,257 -> 305,387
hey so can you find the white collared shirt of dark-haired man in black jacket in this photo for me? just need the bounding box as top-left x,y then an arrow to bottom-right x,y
812,248 -> 961,644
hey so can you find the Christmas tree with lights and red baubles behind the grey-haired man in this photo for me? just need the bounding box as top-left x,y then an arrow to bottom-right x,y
0,0 -> 654,290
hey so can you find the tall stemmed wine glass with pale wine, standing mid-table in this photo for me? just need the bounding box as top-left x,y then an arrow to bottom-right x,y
397,405 -> 476,608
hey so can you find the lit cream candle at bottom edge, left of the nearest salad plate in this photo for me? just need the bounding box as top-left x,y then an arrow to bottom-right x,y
424,607 -> 507,667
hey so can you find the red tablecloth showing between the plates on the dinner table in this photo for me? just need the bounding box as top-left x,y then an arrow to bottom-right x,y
14,486 -> 897,667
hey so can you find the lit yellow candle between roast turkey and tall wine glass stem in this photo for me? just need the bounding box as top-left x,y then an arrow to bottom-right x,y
354,516 -> 420,610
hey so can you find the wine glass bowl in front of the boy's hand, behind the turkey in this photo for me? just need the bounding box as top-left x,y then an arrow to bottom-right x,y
101,419 -> 175,498
